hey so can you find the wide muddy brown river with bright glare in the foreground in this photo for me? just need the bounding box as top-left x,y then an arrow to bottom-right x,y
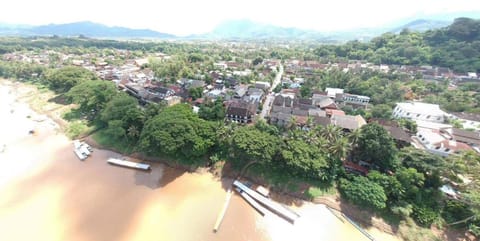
0,79 -> 402,241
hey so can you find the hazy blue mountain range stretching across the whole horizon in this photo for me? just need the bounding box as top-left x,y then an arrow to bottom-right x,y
0,19 -> 468,42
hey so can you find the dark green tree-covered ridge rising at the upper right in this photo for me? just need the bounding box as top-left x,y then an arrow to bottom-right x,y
314,18 -> 480,73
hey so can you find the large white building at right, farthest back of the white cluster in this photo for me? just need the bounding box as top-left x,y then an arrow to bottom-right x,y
393,102 -> 448,123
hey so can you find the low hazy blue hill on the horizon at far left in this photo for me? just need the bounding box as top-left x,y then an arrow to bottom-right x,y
0,21 -> 176,38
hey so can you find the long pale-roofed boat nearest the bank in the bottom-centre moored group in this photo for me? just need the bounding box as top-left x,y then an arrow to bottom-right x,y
233,181 -> 298,223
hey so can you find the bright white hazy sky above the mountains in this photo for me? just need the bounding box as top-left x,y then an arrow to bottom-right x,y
0,0 -> 480,35
